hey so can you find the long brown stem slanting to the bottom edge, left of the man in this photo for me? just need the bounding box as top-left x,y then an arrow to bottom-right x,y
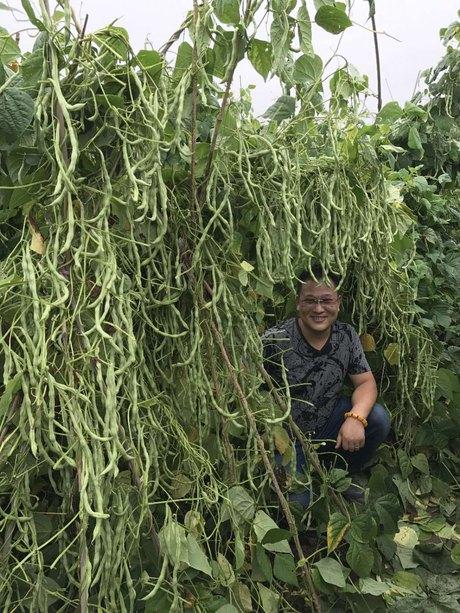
211,321 -> 321,613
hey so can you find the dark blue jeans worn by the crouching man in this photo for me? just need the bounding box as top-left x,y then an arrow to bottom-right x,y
275,396 -> 390,508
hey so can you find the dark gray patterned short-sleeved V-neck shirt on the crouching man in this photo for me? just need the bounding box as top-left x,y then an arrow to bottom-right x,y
262,317 -> 370,433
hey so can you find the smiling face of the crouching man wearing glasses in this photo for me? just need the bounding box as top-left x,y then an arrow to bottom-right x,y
297,279 -> 340,332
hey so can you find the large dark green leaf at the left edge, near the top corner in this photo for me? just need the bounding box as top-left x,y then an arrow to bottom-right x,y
0,87 -> 34,145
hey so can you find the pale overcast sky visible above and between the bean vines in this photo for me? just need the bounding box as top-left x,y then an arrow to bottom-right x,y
4,0 -> 459,113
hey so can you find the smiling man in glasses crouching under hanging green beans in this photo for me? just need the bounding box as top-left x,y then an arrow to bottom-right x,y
262,266 -> 390,506
